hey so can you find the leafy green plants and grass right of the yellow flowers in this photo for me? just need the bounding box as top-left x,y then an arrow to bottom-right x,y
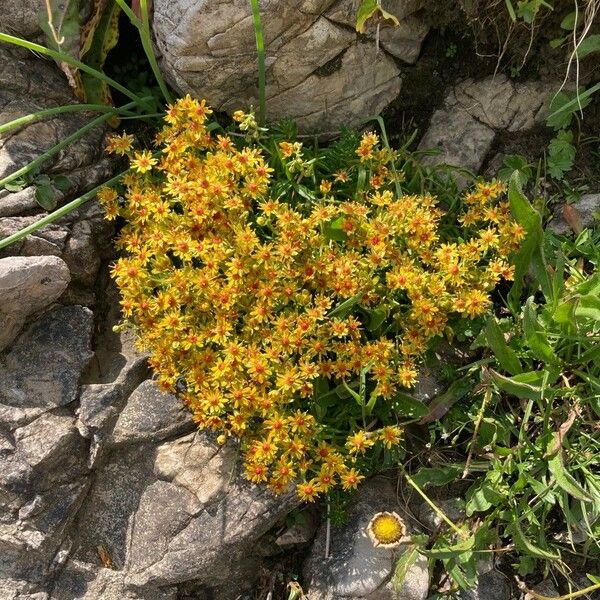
398,174 -> 600,597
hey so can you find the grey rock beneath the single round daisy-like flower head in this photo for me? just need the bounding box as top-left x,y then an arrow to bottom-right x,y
304,477 -> 429,600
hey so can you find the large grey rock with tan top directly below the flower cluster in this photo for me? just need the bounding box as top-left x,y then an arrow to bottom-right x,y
127,434 -> 298,589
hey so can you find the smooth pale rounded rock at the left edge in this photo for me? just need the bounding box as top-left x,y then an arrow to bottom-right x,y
0,256 -> 70,350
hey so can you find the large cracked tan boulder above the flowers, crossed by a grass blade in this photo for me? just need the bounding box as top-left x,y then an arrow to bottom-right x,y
153,0 -> 428,133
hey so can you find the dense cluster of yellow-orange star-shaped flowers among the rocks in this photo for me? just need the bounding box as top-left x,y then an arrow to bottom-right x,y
99,97 -> 524,501
